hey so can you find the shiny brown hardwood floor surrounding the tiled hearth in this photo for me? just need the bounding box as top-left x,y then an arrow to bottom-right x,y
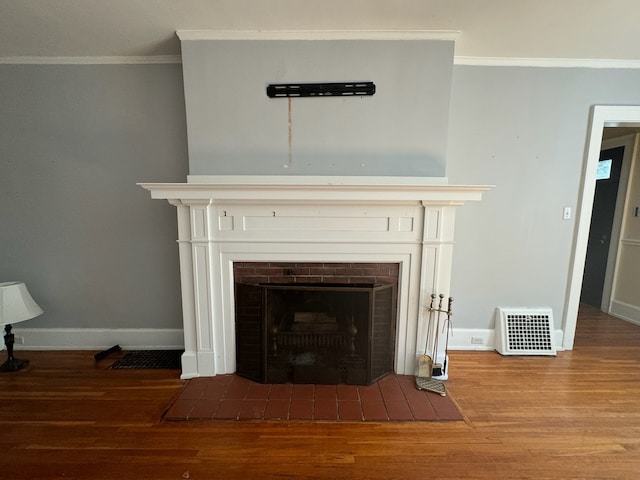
0,309 -> 640,480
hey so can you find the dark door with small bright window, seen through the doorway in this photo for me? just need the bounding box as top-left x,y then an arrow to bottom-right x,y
580,147 -> 624,308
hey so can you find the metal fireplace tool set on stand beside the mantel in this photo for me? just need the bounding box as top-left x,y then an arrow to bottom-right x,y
416,293 -> 453,396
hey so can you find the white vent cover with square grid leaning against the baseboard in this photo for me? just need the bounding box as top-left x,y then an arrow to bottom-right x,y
495,308 -> 556,355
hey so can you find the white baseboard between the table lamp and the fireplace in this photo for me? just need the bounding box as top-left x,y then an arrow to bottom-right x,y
13,326 -> 184,350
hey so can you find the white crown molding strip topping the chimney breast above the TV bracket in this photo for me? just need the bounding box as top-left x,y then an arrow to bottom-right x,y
176,30 -> 460,41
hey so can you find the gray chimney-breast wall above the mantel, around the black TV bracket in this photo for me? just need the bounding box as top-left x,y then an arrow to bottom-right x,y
182,40 -> 453,177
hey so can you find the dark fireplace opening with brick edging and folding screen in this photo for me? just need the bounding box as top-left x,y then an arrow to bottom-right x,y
234,263 -> 399,385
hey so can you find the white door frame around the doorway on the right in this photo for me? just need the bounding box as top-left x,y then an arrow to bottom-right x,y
562,105 -> 640,350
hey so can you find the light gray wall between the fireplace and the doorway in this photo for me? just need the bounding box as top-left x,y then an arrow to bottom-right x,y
447,66 -> 640,328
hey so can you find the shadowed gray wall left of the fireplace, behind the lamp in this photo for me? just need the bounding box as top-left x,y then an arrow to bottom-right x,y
0,65 -> 188,328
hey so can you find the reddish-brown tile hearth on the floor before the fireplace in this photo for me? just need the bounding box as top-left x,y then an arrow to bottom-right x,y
164,375 -> 463,422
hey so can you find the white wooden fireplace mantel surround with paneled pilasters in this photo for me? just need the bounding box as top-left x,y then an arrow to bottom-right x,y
140,176 -> 491,378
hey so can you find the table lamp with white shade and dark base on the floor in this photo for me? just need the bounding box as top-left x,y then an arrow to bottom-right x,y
0,282 -> 42,372
